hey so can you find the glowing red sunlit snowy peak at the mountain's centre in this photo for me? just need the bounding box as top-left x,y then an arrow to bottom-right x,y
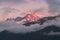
25,13 -> 43,22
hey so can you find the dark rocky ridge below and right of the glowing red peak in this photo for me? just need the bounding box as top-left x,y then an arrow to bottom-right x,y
24,15 -> 60,26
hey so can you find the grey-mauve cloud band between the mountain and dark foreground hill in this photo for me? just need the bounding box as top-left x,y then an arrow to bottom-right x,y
0,17 -> 60,33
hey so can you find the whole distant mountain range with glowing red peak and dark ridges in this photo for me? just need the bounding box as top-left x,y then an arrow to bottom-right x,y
6,13 -> 60,26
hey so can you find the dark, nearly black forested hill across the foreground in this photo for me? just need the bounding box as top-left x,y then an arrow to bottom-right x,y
0,26 -> 60,40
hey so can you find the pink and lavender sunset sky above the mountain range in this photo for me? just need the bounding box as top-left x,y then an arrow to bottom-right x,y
0,0 -> 60,20
